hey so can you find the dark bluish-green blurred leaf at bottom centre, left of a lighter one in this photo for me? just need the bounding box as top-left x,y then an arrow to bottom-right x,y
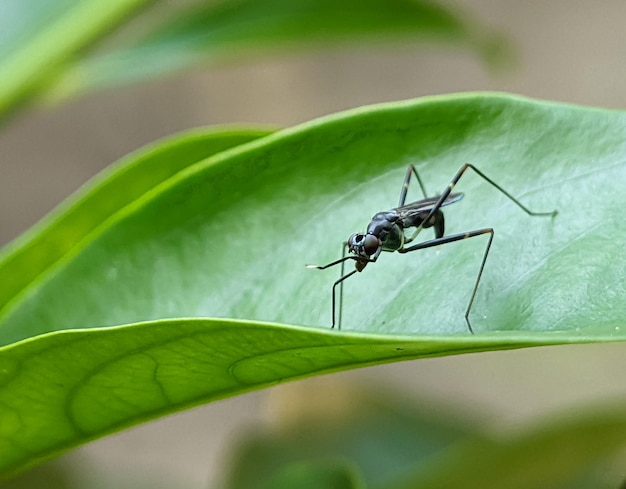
219,382 -> 478,489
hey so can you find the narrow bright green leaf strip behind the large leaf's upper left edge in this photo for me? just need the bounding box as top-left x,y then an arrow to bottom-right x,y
0,127 -> 271,324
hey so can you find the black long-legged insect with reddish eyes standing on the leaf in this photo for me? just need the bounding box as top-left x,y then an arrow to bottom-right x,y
307,164 -> 557,333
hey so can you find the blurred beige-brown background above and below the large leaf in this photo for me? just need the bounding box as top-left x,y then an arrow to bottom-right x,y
0,0 -> 626,489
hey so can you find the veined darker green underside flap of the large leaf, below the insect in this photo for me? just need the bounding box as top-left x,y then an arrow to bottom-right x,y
0,319 -> 512,479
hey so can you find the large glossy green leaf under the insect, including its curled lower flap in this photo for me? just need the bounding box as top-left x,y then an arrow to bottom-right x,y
0,94 -> 626,472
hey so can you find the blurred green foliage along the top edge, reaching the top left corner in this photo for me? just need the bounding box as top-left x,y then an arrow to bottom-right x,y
0,0 -> 507,119
